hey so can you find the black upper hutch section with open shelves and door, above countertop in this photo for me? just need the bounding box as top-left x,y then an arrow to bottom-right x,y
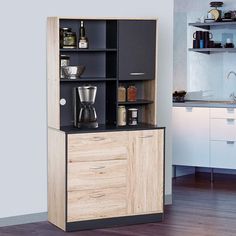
54,18 -> 156,131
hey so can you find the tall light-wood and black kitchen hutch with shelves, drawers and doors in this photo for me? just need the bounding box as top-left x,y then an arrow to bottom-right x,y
47,17 -> 164,231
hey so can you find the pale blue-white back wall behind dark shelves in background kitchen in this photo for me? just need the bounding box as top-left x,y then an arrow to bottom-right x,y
173,0 -> 236,100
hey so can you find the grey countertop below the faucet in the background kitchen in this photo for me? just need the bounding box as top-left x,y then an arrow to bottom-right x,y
173,100 -> 236,108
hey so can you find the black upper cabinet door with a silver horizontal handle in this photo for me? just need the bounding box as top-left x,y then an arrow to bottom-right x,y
119,20 -> 156,80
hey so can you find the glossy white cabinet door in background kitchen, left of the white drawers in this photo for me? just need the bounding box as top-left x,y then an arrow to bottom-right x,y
172,107 -> 210,167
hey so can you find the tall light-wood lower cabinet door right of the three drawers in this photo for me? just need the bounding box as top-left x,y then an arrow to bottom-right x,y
128,130 -> 164,215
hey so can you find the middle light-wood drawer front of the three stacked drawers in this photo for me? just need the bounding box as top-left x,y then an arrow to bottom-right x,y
67,160 -> 127,191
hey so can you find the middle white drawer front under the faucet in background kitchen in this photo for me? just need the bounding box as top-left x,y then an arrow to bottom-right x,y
210,119 -> 236,141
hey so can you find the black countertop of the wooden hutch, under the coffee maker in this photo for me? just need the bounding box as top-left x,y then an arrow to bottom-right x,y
60,123 -> 165,134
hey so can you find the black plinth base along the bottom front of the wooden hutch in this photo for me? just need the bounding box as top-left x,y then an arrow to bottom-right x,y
66,213 -> 163,232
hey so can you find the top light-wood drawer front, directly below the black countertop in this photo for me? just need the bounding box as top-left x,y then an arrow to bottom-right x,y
68,132 -> 129,162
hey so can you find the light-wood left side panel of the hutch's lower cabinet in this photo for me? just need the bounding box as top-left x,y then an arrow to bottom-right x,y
48,128 -> 66,230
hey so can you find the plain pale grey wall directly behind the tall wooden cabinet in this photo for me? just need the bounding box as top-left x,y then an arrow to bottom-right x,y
0,0 -> 173,218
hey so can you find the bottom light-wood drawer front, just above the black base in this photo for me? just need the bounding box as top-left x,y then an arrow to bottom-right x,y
67,188 -> 127,222
